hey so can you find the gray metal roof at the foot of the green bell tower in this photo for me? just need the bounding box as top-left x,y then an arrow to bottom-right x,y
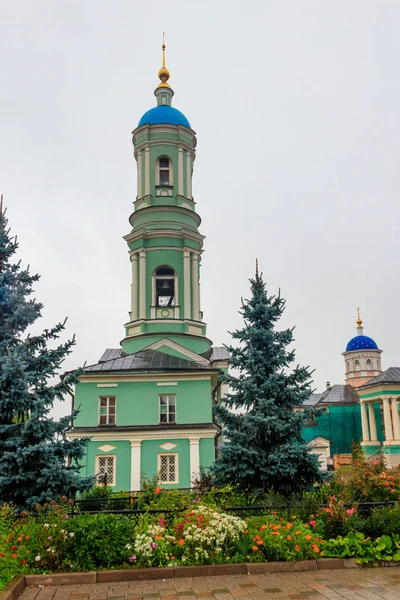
84,350 -> 216,373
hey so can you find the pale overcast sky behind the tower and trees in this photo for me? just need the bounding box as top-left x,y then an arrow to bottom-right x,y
0,0 -> 400,415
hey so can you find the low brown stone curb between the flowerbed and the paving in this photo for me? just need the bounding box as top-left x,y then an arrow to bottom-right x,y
0,558 -> 362,600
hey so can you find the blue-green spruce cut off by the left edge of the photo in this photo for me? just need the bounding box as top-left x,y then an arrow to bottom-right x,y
0,203 -> 92,508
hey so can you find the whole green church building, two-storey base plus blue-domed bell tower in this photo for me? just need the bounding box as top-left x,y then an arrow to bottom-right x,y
69,44 -> 228,490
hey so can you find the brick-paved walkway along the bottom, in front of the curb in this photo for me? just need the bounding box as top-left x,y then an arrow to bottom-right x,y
21,567 -> 400,600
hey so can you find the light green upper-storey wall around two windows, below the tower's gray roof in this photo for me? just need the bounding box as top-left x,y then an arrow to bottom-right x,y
75,377 -> 212,431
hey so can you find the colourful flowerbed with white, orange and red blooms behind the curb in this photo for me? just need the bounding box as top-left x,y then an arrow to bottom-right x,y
0,457 -> 400,589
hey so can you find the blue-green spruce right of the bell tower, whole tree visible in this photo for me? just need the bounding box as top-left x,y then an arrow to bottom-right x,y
213,271 -> 321,496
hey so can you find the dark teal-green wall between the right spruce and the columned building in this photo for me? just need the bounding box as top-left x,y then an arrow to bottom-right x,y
303,404 -> 362,456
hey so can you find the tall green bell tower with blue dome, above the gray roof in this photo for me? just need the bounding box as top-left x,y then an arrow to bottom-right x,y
121,43 -> 211,358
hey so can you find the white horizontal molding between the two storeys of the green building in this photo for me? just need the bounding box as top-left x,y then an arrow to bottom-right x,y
68,429 -> 218,444
